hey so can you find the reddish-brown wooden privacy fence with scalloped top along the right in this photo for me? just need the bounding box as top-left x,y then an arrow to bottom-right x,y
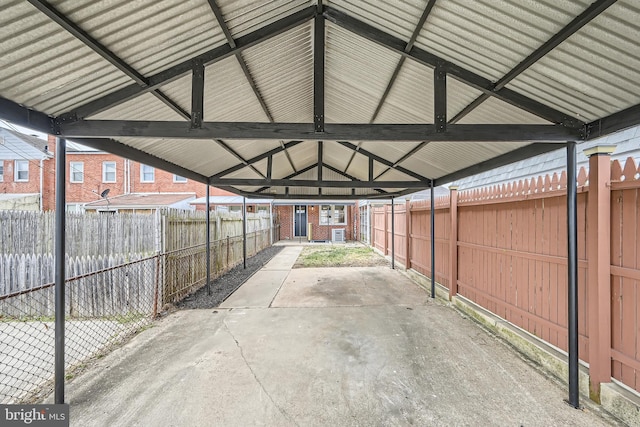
371,149 -> 640,399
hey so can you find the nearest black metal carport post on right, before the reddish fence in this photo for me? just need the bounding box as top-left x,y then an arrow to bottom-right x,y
567,141 -> 580,408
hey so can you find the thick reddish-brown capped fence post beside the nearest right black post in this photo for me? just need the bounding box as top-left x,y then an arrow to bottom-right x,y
584,146 -> 615,403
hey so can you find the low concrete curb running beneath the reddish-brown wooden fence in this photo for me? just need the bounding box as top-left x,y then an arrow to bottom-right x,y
399,270 -> 640,425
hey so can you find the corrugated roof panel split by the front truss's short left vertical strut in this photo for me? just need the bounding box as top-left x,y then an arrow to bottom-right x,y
160,57 -> 269,122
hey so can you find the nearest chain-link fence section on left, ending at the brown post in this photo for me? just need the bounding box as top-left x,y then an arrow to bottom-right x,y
0,256 -> 159,404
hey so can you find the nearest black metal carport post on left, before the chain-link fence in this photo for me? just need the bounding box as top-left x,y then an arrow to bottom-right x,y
54,138 -> 67,404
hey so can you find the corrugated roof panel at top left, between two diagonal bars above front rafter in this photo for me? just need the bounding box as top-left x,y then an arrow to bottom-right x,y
52,0 -> 226,75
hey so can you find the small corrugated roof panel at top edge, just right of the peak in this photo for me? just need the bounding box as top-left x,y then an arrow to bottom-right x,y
324,0 -> 427,41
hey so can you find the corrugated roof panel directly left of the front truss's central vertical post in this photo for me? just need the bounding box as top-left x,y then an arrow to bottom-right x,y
242,23 -> 313,123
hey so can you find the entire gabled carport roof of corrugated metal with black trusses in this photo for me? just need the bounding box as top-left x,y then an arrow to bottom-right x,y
0,0 -> 640,199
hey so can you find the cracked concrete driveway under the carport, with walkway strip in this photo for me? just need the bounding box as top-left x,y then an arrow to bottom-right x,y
61,247 -> 610,426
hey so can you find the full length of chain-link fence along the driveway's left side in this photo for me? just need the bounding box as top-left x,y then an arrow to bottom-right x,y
0,229 -> 271,404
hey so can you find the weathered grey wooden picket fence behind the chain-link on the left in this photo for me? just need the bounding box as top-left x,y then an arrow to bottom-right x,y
0,210 -> 271,317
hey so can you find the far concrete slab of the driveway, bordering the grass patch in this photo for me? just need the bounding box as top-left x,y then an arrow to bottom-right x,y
272,267 -> 429,307
